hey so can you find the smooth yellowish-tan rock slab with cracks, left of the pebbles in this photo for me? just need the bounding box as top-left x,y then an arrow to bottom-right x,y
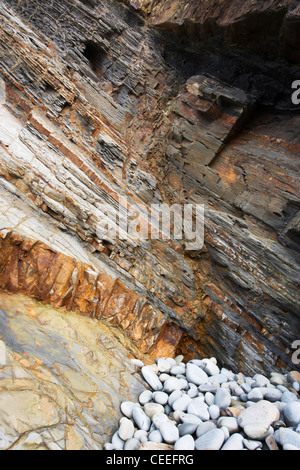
0,294 -> 144,450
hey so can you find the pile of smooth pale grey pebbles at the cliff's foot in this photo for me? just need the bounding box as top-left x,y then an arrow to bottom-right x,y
104,356 -> 300,451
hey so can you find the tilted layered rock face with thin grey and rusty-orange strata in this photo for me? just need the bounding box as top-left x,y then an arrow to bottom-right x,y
0,0 -> 300,372
